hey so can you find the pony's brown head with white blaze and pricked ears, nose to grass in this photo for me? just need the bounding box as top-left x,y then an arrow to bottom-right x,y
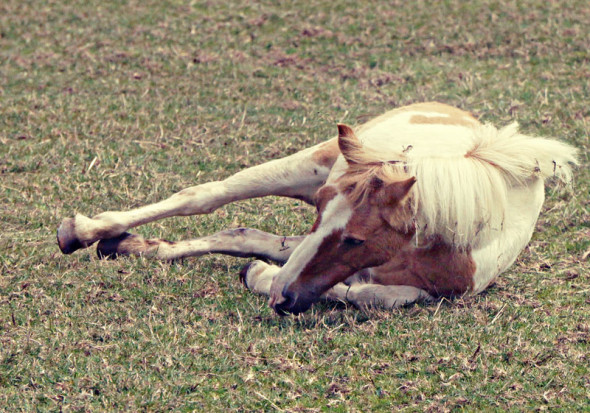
270,125 -> 416,314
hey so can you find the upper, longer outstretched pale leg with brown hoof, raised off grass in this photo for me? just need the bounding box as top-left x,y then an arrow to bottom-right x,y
57,139 -> 339,254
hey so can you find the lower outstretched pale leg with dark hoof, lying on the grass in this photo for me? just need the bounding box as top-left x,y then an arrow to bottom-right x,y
97,228 -> 305,263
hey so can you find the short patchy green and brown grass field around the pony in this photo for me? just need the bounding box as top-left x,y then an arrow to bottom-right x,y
0,0 -> 590,412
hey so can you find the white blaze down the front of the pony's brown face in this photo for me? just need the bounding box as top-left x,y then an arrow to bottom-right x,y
270,193 -> 352,305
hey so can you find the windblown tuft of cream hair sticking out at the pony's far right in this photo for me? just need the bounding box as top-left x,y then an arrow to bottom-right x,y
465,122 -> 578,185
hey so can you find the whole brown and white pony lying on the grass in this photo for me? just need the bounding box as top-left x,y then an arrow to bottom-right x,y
57,102 -> 577,315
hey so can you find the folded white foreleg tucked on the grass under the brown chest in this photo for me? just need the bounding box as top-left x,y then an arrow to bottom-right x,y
322,283 -> 433,309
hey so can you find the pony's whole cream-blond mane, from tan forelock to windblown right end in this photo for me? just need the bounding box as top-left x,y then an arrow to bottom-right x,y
339,123 -> 577,248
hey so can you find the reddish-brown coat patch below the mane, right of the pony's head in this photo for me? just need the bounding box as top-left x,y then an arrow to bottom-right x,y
372,238 -> 476,297
